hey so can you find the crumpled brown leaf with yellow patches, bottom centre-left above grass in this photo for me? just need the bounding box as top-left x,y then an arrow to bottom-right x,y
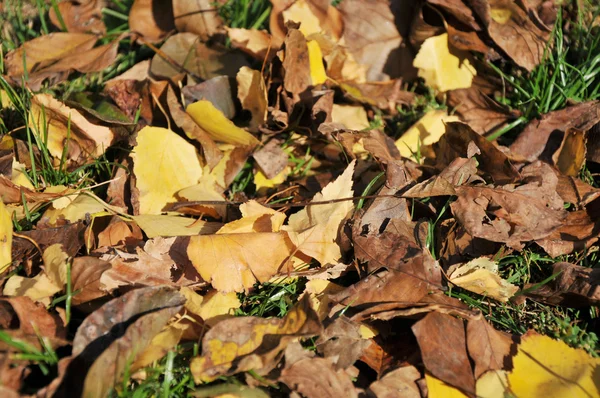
190,296 -> 322,383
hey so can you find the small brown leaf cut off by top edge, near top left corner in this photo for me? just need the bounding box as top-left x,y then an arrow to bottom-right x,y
49,0 -> 106,35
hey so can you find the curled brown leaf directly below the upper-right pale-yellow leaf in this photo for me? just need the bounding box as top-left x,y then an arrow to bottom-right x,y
448,86 -> 517,135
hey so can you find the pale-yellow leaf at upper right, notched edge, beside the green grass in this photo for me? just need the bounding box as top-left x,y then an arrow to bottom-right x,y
413,33 -> 477,92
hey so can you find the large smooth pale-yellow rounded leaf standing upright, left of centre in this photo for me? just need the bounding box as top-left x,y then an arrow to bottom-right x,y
131,127 -> 202,214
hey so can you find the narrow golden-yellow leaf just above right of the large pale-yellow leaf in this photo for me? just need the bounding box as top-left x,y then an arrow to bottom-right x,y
185,100 -> 259,147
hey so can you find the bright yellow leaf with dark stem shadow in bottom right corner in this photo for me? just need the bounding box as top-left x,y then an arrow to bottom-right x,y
508,332 -> 600,398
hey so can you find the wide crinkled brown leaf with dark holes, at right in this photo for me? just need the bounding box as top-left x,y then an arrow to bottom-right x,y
450,186 -> 567,248
